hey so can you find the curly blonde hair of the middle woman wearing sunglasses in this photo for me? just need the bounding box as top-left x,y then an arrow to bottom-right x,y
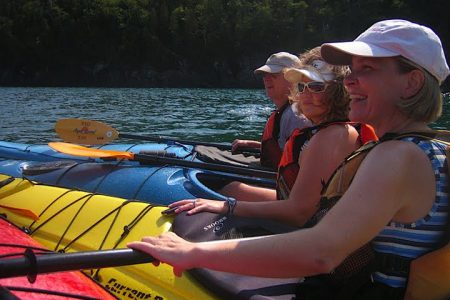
290,46 -> 350,122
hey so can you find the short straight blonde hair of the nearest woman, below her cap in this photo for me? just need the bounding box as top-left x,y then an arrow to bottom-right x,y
396,56 -> 443,123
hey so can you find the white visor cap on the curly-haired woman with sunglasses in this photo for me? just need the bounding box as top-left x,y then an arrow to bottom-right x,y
284,59 -> 336,83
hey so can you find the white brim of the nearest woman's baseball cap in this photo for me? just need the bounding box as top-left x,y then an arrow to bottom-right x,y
320,41 -> 399,65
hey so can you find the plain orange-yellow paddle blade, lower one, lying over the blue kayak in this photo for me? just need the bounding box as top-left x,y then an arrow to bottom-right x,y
48,142 -> 134,160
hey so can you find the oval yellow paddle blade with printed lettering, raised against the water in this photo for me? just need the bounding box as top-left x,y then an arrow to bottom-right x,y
55,119 -> 119,145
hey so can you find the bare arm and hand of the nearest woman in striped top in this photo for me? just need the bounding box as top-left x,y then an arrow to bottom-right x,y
129,141 -> 435,277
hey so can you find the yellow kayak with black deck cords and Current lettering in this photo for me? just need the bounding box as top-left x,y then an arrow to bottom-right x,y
0,175 -> 214,300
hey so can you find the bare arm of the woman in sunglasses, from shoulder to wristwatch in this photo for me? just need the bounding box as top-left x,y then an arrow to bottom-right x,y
227,125 -> 359,226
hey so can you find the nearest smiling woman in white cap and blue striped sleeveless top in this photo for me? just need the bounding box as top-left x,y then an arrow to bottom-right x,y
129,20 -> 450,299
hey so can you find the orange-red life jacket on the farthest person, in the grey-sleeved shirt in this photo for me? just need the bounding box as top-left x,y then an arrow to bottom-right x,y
260,103 -> 289,170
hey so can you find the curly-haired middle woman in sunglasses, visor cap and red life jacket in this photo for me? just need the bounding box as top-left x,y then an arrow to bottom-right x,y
160,47 -> 376,227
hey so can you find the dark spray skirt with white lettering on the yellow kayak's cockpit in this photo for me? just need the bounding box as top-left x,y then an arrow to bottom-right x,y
172,212 -> 300,300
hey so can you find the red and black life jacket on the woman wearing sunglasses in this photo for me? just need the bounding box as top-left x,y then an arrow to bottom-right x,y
277,121 -> 378,199
